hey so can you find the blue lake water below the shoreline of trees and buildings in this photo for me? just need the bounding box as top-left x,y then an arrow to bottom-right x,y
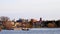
0,28 -> 60,34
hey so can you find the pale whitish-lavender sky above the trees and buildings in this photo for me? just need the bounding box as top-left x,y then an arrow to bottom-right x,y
0,0 -> 60,20
